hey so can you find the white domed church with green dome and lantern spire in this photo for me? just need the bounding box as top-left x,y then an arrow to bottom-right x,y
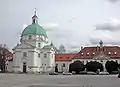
13,11 -> 55,73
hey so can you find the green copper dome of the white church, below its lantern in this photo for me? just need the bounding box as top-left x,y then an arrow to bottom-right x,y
22,23 -> 46,36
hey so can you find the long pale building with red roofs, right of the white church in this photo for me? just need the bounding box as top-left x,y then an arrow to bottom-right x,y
55,41 -> 120,71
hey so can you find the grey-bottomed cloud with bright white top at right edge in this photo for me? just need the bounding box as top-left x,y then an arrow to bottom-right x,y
96,19 -> 120,31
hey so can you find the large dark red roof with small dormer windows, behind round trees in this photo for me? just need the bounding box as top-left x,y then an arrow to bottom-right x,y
74,46 -> 120,58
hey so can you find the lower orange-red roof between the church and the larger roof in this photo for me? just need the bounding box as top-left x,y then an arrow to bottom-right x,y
55,53 -> 76,61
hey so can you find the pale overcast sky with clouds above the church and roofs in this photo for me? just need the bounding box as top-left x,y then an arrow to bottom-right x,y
0,0 -> 120,49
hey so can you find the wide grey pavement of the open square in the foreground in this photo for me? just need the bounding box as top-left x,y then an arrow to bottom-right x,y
0,73 -> 120,87
